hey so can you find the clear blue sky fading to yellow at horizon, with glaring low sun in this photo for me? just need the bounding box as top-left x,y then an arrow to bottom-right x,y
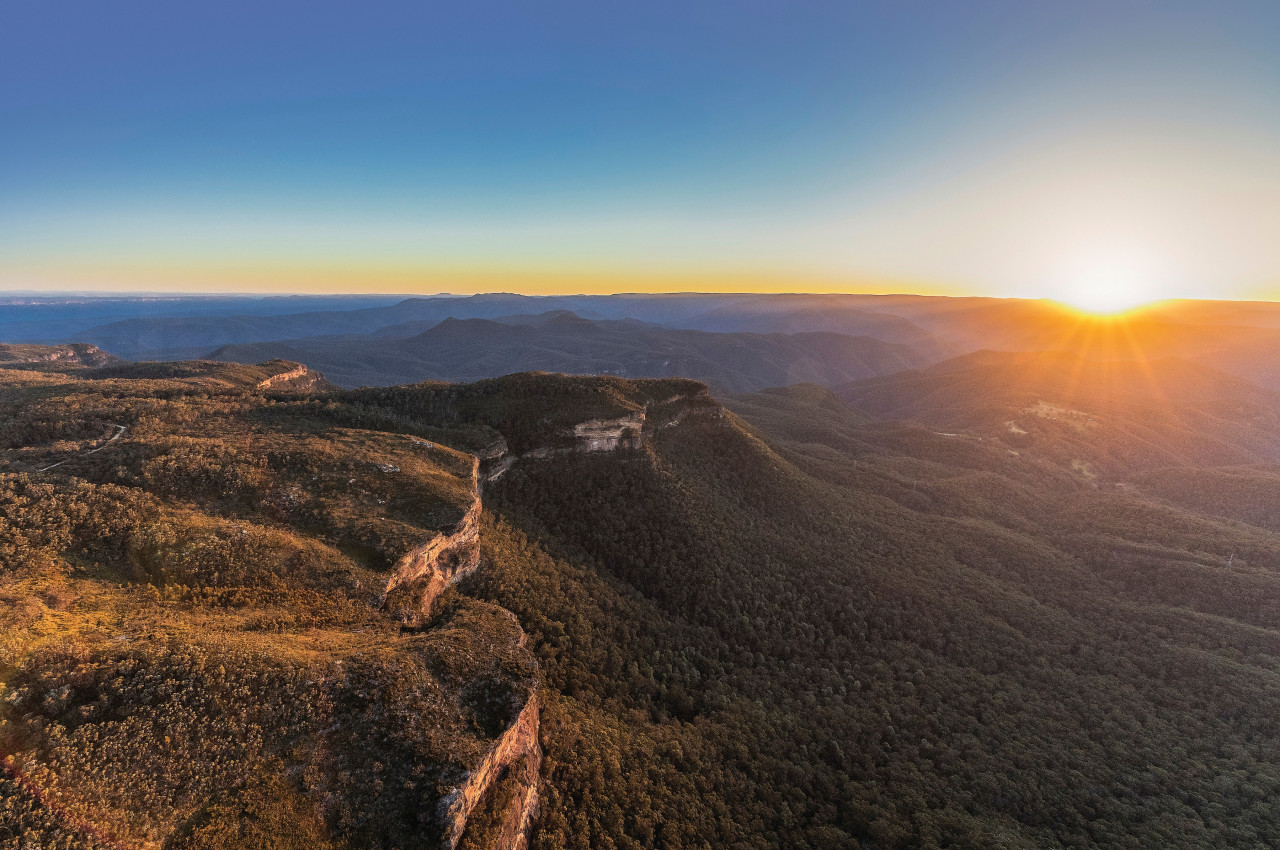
0,0 -> 1280,298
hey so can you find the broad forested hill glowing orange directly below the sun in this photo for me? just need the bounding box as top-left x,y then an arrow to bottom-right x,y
836,352 -> 1280,474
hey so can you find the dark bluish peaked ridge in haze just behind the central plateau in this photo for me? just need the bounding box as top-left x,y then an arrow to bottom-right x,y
211,310 -> 942,392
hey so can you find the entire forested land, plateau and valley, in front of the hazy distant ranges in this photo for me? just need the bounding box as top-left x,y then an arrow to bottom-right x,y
0,343 -> 1280,847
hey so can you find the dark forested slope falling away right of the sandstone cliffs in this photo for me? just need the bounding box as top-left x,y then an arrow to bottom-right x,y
468,381 -> 1280,847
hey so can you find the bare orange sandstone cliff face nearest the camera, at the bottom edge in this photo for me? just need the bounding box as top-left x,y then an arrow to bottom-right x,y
438,693 -> 543,850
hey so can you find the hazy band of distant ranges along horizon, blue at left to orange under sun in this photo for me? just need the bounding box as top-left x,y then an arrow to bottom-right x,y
12,293 -> 1280,392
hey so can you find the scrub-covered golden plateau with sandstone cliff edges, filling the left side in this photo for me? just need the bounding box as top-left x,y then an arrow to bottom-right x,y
0,366 -> 737,850
